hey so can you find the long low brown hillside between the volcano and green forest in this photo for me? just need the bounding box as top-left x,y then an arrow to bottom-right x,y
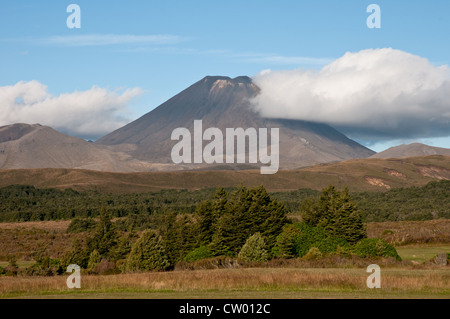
0,156 -> 450,193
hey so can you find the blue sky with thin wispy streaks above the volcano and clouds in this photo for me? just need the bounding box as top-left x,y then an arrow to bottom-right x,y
0,0 -> 450,151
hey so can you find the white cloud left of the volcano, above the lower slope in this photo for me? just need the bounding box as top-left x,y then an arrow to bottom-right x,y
0,81 -> 142,138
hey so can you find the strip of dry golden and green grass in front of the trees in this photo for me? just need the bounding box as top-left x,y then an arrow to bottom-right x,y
0,267 -> 450,299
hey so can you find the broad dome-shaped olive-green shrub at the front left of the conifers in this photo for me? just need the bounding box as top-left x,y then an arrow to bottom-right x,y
126,230 -> 169,271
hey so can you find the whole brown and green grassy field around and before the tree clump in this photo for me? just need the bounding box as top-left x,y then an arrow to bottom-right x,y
0,216 -> 450,299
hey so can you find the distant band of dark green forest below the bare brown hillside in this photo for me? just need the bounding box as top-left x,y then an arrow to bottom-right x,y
0,180 -> 450,222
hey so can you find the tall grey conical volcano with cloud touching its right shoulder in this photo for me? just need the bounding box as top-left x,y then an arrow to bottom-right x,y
96,76 -> 374,168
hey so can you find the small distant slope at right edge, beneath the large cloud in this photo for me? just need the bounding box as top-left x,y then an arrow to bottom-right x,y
371,143 -> 450,159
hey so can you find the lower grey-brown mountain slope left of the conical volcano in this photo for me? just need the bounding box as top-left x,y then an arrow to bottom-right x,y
0,124 -> 152,172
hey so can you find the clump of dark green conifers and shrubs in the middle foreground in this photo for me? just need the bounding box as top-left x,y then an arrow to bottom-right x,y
6,186 -> 399,274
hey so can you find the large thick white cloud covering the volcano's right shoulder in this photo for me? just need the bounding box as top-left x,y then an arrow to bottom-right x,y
252,48 -> 450,140
